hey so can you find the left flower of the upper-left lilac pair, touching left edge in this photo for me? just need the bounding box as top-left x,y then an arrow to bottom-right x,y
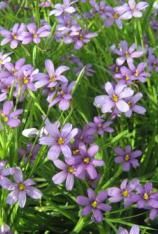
0,24 -> 26,49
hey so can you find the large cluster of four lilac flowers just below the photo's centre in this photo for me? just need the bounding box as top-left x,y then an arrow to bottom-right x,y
39,122 -> 104,190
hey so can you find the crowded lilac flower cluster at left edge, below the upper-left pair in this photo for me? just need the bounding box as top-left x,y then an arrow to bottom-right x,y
0,58 -> 38,101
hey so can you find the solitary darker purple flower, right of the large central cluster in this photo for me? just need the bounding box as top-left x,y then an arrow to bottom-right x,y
115,145 -> 142,171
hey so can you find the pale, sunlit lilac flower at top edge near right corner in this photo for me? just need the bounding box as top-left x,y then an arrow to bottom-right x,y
121,0 -> 149,19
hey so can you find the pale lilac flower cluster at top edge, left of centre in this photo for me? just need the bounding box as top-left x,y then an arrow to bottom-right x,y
50,0 -> 97,50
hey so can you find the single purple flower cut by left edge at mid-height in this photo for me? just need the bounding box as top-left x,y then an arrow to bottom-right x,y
0,101 -> 23,128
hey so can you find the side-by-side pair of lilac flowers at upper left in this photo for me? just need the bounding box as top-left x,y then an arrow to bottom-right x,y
0,23 -> 51,49
